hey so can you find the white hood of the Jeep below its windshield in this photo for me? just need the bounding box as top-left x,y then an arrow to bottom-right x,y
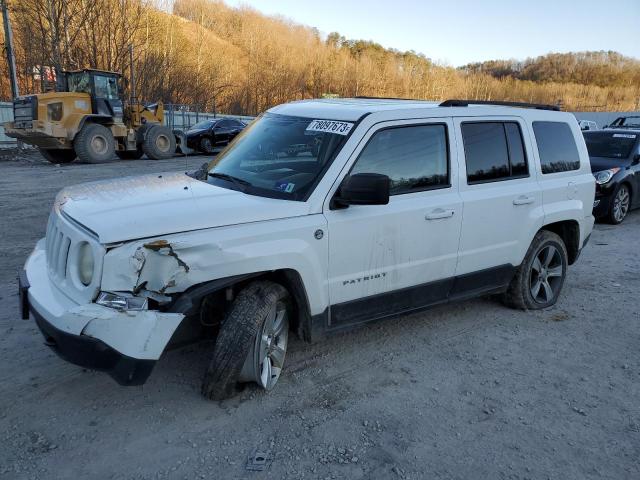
56,173 -> 309,243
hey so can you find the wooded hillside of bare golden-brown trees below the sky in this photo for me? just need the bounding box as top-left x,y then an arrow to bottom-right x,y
0,0 -> 640,114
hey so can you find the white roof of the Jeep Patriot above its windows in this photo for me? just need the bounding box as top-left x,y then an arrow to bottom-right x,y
268,98 -> 562,121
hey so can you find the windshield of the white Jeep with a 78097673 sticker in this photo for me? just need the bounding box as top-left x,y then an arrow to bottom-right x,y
208,113 -> 353,201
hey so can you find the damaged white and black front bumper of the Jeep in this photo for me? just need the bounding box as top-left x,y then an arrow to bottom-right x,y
19,240 -> 184,385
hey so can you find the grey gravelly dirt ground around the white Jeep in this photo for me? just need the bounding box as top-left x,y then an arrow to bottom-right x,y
0,151 -> 640,480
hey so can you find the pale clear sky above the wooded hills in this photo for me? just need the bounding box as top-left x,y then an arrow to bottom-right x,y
225,0 -> 640,66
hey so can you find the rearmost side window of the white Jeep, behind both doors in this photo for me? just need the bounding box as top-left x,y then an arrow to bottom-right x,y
533,122 -> 580,174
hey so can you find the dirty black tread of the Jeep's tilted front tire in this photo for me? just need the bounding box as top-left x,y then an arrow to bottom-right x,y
202,280 -> 289,400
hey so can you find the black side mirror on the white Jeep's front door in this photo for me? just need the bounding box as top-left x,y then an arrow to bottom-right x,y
332,173 -> 391,208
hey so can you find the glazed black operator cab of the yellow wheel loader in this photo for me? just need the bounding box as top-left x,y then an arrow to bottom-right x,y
65,69 -> 123,122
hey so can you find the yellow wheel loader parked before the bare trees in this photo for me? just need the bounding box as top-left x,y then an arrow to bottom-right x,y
4,69 -> 180,163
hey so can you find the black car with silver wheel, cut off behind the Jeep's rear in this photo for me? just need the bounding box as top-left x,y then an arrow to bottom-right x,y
584,129 -> 640,224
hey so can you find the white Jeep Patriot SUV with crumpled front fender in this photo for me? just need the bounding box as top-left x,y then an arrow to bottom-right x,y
19,99 -> 594,399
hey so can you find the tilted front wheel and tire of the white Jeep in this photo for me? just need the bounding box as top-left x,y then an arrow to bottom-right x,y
202,281 -> 291,400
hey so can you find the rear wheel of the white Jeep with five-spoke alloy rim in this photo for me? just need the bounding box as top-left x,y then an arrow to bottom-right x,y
502,230 -> 568,310
